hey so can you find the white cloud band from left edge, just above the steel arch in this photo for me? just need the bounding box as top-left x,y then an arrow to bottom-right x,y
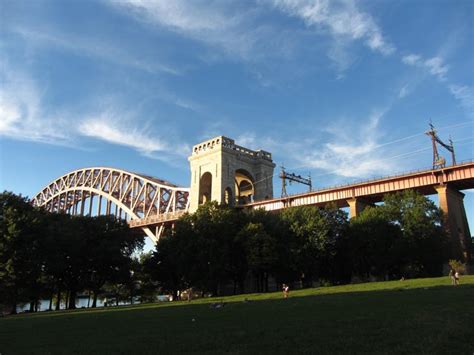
0,62 -> 190,160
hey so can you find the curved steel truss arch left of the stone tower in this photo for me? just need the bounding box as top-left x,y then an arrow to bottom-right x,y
32,167 -> 189,243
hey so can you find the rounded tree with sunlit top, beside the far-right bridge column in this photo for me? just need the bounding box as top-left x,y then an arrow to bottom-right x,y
350,190 -> 449,278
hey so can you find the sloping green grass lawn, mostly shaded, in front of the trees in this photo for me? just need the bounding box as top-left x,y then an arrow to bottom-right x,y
0,276 -> 474,355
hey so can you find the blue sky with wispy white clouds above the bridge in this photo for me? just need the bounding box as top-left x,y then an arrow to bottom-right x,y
0,0 -> 474,236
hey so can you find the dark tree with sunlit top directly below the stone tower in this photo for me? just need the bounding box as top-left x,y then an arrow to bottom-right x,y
147,202 -> 247,294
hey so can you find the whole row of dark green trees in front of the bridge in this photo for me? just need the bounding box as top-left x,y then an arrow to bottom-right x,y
0,191 -> 456,314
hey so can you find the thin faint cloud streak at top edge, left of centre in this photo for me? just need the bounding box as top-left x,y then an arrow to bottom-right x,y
105,0 -> 266,60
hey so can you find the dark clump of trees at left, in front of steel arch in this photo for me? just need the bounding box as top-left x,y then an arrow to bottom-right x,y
0,192 -> 144,312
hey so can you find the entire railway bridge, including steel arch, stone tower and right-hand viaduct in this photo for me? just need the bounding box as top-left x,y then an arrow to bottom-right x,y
33,136 -> 474,260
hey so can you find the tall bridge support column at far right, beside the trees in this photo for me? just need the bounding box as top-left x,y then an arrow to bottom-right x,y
436,185 -> 471,262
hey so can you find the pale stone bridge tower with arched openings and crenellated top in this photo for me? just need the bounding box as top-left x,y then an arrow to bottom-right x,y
188,136 -> 275,212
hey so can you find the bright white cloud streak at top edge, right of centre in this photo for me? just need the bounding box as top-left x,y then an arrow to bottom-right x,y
272,0 -> 395,55
